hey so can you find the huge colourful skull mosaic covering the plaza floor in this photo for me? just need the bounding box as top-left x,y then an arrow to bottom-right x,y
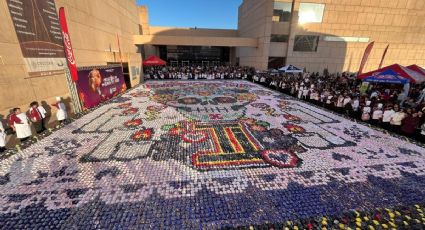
0,81 -> 425,229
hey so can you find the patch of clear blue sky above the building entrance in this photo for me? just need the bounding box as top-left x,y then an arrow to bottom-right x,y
137,0 -> 242,29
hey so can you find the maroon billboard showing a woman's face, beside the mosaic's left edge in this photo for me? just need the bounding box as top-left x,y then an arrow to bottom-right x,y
76,66 -> 127,109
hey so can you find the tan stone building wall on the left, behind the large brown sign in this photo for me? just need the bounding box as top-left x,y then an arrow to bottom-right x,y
0,0 -> 141,116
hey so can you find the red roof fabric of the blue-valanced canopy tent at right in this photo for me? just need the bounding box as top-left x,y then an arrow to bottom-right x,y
357,64 -> 425,84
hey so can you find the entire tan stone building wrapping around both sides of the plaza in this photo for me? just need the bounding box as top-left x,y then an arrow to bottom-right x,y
0,0 -> 425,115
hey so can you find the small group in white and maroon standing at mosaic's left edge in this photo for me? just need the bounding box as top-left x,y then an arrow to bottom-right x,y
0,97 -> 68,153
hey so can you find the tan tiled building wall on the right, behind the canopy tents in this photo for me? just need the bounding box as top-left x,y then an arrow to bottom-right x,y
287,0 -> 425,72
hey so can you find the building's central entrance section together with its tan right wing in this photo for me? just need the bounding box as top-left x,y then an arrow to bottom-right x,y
135,0 -> 425,72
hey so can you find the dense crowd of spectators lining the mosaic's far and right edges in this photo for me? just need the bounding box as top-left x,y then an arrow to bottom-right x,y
145,66 -> 425,143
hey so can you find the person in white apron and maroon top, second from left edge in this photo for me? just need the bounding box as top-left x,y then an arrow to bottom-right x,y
10,108 -> 32,143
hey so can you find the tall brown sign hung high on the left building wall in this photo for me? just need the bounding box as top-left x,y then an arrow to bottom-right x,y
6,0 -> 66,77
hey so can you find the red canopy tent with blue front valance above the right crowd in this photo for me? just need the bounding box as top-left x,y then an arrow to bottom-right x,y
357,64 -> 425,84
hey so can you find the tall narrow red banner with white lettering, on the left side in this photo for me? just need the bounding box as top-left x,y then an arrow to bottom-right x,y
59,7 -> 78,81
